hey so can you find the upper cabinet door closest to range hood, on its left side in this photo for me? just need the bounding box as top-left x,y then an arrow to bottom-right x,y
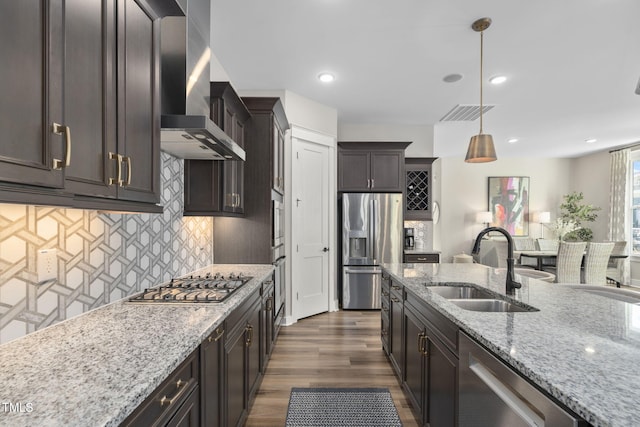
113,0 -> 160,203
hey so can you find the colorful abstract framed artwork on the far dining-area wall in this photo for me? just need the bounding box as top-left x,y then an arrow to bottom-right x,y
489,176 -> 529,236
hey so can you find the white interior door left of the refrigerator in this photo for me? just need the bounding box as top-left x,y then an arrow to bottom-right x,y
292,139 -> 333,319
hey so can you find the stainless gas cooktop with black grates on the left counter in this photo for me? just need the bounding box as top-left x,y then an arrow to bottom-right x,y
129,273 -> 252,303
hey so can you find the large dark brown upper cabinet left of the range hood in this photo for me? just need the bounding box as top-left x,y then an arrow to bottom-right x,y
0,0 -> 168,212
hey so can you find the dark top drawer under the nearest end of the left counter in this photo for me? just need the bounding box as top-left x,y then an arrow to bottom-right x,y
123,350 -> 199,426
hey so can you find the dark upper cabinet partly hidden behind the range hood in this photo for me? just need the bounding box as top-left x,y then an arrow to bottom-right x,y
184,82 -> 251,216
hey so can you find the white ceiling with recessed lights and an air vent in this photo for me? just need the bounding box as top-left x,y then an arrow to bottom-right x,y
211,0 -> 640,157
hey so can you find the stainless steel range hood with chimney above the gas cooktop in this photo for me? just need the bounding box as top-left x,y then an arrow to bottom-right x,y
160,0 -> 245,160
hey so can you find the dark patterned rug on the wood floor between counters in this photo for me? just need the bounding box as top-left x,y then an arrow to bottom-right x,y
286,387 -> 402,427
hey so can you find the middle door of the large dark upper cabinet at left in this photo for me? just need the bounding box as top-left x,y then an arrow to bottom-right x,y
64,0 -> 117,197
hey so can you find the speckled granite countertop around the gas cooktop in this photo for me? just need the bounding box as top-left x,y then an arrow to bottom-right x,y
0,264 -> 273,427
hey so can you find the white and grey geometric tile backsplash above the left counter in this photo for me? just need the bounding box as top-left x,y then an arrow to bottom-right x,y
0,152 -> 213,343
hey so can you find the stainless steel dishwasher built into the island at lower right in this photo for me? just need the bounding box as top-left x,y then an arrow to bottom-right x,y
458,332 -> 588,427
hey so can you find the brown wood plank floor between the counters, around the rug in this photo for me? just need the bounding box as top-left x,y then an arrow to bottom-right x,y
245,310 -> 418,427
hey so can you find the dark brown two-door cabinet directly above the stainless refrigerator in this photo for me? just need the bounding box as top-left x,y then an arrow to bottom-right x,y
338,142 -> 410,193
